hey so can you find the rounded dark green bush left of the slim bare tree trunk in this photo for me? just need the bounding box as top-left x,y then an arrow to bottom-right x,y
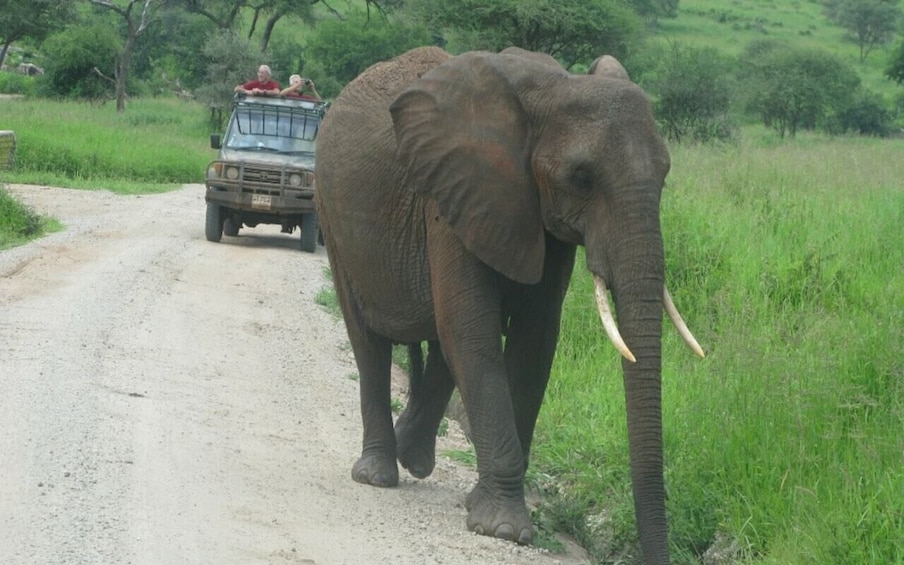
42,25 -> 121,98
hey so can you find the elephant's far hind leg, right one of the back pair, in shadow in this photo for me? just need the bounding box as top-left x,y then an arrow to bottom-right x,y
395,341 -> 455,479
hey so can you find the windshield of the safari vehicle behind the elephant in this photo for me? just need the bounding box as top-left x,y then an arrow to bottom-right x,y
223,105 -> 321,153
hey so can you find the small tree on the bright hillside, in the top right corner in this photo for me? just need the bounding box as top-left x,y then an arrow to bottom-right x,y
825,0 -> 902,62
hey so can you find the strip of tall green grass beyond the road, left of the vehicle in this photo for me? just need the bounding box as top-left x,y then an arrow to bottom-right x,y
0,98 -> 213,193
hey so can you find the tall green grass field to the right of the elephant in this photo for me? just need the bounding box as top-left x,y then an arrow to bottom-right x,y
533,131 -> 904,564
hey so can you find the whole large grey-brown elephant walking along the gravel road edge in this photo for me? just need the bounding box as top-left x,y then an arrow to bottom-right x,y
317,47 -> 669,563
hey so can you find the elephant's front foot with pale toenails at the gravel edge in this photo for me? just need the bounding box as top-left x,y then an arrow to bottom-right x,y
465,483 -> 533,545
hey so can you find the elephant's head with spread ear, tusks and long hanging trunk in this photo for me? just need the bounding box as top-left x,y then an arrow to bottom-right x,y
390,52 -> 702,563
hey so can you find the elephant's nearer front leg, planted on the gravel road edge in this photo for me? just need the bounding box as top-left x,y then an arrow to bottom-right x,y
429,229 -> 532,544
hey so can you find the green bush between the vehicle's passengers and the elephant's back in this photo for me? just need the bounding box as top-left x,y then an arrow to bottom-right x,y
306,11 -> 431,98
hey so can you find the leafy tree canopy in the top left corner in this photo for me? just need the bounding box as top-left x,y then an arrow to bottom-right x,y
0,0 -> 72,65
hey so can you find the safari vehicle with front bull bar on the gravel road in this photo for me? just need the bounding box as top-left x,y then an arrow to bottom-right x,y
204,94 -> 326,252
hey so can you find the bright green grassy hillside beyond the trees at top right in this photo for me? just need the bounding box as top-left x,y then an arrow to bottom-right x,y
654,0 -> 902,101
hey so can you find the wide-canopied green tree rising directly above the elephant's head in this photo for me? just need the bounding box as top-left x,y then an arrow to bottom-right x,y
408,0 -> 643,69
